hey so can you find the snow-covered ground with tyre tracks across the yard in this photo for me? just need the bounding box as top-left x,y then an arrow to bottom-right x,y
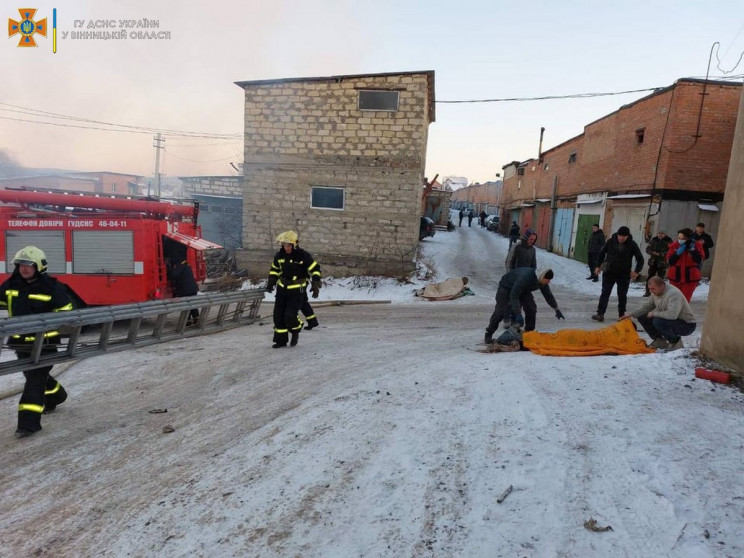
0,221 -> 744,558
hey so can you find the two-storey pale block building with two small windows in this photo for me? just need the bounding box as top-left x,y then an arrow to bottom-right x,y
231,71 -> 434,277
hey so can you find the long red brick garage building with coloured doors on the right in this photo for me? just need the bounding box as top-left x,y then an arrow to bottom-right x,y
500,79 -> 741,274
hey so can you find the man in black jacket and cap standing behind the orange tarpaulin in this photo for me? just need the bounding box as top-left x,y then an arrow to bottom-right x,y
592,226 -> 643,322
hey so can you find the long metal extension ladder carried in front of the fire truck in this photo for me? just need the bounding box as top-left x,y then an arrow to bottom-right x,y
0,289 -> 264,376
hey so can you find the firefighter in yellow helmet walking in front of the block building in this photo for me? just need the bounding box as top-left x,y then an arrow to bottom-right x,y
266,231 -> 320,349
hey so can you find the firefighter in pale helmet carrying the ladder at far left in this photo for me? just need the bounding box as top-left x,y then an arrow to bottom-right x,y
0,246 -> 72,438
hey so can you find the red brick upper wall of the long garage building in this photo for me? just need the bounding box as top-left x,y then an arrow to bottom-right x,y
501,81 -> 742,207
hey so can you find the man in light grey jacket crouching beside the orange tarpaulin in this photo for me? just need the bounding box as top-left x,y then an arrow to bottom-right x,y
620,276 -> 696,351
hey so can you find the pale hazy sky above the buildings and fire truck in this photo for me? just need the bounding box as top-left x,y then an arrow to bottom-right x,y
0,0 -> 744,182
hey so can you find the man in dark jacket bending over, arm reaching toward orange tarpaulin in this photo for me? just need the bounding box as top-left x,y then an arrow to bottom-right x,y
485,267 -> 565,343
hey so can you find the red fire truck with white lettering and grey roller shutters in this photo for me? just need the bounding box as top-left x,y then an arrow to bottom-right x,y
0,190 -> 222,306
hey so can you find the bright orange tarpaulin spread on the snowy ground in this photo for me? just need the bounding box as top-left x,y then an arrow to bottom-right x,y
522,320 -> 656,356
